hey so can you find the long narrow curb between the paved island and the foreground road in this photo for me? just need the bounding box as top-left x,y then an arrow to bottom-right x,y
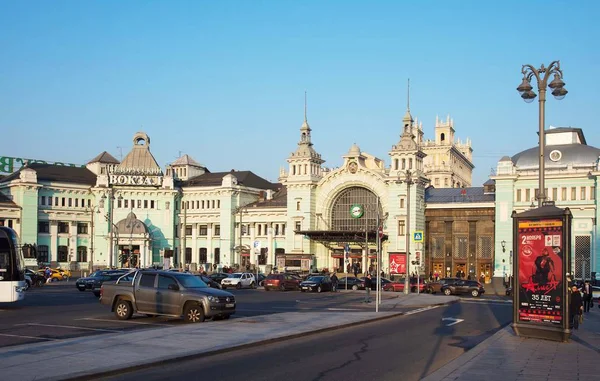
57,300 -> 459,381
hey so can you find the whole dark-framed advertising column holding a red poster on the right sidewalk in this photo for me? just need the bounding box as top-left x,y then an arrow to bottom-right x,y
513,206 -> 571,341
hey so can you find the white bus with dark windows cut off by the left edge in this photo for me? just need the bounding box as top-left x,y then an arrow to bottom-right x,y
0,226 -> 27,302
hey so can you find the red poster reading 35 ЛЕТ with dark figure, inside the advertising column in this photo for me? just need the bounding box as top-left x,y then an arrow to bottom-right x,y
518,219 -> 563,324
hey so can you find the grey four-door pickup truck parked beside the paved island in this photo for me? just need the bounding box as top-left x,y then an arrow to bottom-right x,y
100,270 -> 236,323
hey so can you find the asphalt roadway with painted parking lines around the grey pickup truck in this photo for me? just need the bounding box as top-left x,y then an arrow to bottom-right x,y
0,281 -> 446,347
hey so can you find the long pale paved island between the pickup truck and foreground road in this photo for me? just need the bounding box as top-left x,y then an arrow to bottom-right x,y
0,294 -> 458,381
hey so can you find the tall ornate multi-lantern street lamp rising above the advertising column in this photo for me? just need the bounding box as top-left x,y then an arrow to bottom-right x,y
517,61 -> 568,207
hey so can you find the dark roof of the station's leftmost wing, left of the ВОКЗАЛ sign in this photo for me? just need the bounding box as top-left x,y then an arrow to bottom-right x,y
2,163 -> 96,185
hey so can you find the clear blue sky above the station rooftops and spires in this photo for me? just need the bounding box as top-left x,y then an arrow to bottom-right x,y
0,0 -> 600,185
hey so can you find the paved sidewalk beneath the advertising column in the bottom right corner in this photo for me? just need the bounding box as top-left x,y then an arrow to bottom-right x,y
422,306 -> 600,381
